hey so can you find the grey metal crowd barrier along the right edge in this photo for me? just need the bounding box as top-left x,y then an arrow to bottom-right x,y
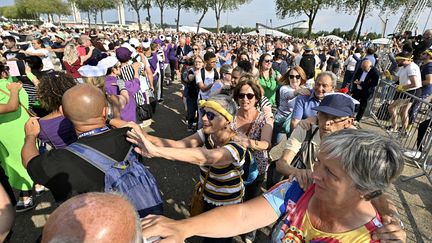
370,80 -> 432,184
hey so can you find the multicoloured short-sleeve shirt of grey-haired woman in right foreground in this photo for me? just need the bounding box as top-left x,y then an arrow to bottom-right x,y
264,181 -> 382,243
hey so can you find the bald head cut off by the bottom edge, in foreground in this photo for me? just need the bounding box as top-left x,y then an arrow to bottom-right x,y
42,192 -> 142,243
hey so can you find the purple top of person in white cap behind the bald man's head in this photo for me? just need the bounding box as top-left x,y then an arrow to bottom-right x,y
105,76 -> 140,122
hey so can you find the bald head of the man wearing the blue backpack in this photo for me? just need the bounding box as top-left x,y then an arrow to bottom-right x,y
62,84 -> 106,125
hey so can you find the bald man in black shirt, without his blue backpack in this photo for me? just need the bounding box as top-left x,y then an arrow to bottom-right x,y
22,84 -> 131,201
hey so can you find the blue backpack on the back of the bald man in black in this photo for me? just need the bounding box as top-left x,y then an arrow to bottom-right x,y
66,142 -> 163,218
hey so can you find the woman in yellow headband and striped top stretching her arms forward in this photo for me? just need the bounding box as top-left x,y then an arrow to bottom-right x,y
128,95 -> 253,242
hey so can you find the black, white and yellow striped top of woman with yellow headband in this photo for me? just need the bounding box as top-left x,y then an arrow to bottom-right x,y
198,130 -> 253,206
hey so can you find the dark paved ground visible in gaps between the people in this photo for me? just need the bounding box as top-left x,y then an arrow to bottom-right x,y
7,80 -> 432,242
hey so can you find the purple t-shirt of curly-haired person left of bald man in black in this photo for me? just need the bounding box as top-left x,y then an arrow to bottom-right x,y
39,116 -> 78,149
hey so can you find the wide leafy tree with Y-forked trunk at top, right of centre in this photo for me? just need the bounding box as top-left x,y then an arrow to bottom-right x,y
276,0 -> 332,38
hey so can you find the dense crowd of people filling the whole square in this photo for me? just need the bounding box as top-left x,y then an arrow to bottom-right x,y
0,22 -> 432,242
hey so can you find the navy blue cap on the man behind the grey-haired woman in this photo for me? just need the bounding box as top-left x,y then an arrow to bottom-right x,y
312,93 -> 359,117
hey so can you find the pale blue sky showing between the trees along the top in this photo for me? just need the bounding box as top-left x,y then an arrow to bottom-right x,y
0,0 -> 432,34
